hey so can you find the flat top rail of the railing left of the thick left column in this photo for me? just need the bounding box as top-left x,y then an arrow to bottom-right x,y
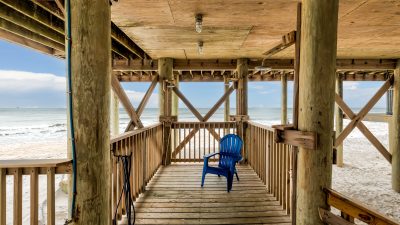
0,159 -> 72,169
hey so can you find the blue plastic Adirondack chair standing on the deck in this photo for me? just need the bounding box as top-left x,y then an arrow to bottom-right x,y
201,134 -> 243,192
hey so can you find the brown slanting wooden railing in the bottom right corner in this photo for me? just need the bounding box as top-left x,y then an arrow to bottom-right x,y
319,189 -> 399,225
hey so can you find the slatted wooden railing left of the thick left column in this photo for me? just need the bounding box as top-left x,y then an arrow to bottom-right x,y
0,159 -> 71,225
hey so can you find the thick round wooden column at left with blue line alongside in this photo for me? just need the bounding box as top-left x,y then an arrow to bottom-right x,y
71,0 -> 111,225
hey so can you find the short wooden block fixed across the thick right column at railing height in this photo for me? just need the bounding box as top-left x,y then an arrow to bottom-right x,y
272,124 -> 318,150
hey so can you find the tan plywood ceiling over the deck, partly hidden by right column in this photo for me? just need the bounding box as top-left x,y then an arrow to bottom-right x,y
112,0 -> 400,59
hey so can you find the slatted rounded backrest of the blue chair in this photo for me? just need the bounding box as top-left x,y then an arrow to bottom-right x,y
219,134 -> 243,167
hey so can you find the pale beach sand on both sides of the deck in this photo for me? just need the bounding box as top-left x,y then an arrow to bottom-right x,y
0,120 -> 400,224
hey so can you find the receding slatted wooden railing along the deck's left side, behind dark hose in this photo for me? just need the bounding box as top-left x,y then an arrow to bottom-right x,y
110,123 -> 163,220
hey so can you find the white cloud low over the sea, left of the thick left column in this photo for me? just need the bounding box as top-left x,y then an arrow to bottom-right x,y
0,70 -> 66,93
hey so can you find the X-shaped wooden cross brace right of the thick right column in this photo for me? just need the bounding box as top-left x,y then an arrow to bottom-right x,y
335,76 -> 393,163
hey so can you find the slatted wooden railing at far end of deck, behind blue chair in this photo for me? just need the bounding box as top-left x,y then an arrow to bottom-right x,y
170,122 -> 237,162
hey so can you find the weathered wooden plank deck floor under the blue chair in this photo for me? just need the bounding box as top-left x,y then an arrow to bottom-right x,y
136,164 -> 290,224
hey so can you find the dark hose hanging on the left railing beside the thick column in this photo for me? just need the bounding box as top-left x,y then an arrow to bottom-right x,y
113,153 -> 136,225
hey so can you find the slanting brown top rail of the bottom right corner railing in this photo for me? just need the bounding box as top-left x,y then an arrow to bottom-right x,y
324,188 -> 399,225
